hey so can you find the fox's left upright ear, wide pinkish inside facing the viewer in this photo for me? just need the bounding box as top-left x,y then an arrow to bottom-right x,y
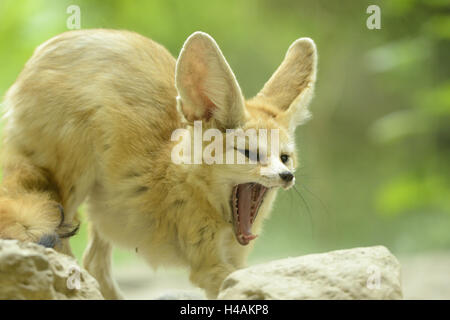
175,32 -> 245,129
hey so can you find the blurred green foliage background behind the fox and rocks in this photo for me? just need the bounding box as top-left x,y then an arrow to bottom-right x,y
0,0 -> 450,263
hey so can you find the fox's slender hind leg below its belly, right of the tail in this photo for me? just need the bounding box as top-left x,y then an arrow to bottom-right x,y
83,223 -> 123,300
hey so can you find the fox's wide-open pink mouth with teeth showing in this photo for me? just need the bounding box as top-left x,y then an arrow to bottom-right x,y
231,183 -> 267,246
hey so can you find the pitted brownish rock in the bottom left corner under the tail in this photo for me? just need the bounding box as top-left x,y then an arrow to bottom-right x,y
0,240 -> 103,300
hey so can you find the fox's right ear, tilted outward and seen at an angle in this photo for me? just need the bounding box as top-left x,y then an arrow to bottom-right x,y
256,38 -> 317,130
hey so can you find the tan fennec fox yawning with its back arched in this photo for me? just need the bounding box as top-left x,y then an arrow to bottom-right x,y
0,29 -> 317,299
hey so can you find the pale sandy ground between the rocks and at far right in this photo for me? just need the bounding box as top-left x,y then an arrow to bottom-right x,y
115,252 -> 450,300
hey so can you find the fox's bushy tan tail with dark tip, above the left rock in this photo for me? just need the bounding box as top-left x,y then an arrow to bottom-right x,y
0,156 -> 79,247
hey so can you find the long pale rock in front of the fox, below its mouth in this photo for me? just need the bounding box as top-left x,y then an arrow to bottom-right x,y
219,246 -> 402,299
